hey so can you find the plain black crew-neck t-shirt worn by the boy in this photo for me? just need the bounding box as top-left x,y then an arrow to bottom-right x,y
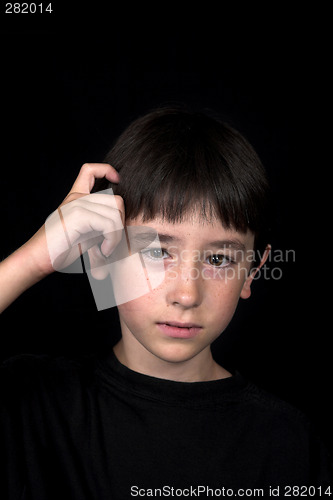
0,353 -> 333,500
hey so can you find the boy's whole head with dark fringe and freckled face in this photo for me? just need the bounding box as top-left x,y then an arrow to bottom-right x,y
90,109 -> 268,377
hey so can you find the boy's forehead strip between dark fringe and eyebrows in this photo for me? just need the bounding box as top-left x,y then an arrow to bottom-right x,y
126,212 -> 254,250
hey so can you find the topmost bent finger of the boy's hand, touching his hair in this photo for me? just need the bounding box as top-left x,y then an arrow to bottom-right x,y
70,163 -> 119,194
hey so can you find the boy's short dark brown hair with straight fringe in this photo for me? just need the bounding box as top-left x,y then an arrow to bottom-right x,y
94,108 -> 268,258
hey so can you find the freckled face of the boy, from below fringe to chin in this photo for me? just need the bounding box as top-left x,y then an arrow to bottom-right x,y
111,209 -> 254,370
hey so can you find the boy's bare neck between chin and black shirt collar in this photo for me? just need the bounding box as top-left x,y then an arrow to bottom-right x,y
113,339 -> 231,382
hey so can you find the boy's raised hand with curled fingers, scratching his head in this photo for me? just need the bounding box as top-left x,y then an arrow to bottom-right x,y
45,164 -> 125,271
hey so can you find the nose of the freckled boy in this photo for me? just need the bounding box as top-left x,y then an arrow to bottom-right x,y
166,263 -> 204,309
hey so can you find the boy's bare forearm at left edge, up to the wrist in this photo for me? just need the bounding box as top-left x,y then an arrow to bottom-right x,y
0,229 -> 53,313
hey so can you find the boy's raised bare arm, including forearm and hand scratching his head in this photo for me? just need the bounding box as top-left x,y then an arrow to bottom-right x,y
0,163 -> 124,312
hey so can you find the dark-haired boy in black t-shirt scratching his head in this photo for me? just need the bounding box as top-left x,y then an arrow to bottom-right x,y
0,109 -> 332,500
